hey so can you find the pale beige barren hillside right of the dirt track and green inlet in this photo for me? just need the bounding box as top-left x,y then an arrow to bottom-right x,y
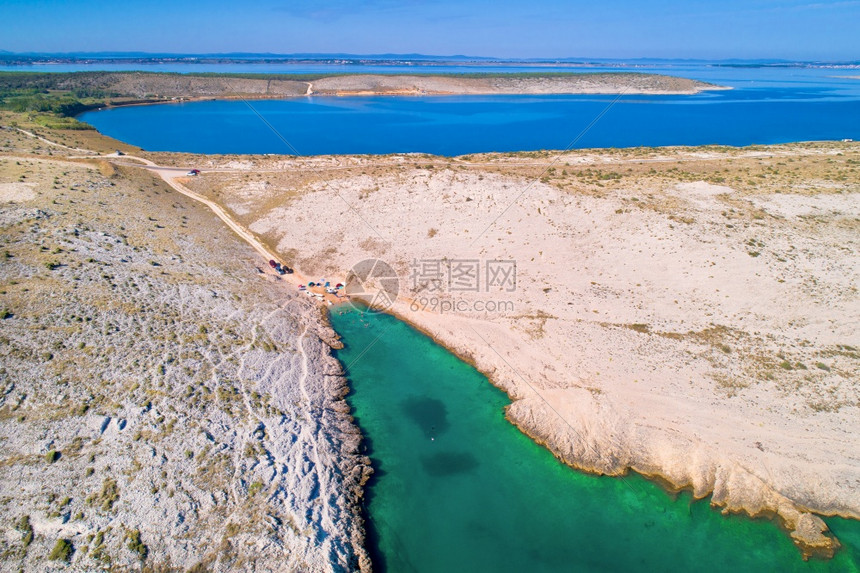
188,143 -> 860,554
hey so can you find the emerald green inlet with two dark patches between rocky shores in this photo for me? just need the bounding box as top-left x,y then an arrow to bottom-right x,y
331,307 -> 860,572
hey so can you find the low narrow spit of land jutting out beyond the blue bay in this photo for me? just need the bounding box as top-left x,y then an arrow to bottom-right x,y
0,72 -> 731,109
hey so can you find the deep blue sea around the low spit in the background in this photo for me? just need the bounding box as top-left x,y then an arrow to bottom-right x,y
74,65 -> 860,156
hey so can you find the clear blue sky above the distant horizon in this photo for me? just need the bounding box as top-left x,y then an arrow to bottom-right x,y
0,0 -> 860,60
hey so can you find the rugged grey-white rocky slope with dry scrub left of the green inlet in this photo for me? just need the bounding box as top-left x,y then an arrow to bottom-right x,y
0,129 -> 370,571
